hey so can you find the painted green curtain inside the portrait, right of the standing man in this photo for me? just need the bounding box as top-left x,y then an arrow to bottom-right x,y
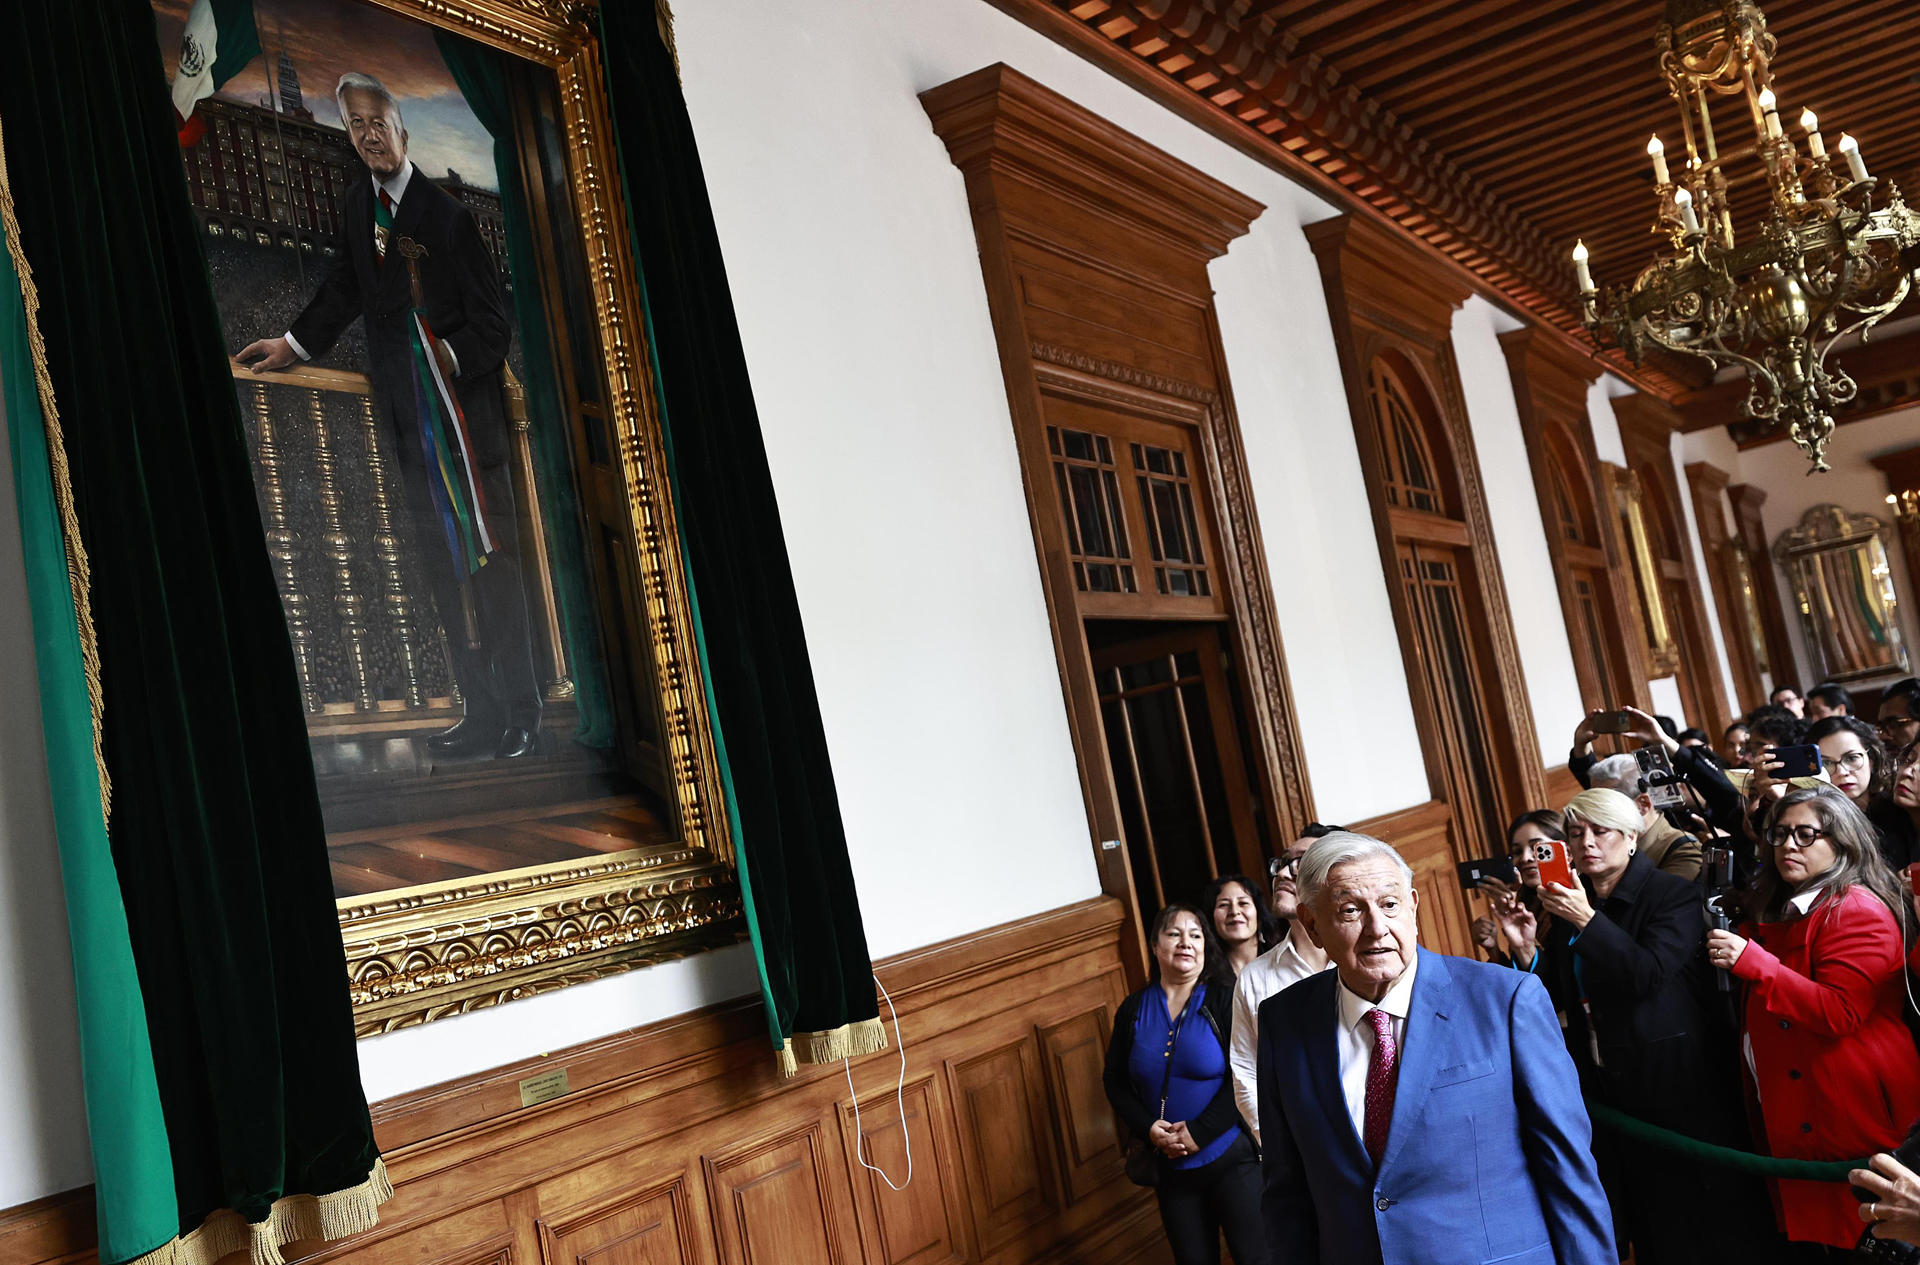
434,31 -> 614,747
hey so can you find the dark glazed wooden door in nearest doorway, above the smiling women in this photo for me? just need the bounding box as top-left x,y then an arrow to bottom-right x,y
1094,624 -> 1263,927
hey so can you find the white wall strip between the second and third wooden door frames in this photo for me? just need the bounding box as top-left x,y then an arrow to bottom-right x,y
1453,296 -> 1586,766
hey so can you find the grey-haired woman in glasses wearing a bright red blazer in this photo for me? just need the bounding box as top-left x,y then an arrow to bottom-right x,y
1707,787 -> 1920,1248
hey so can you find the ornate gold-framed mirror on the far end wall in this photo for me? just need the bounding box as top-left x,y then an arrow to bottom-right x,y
1774,505 -> 1908,681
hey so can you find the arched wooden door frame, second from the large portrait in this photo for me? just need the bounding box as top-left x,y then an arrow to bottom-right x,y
1306,215 -> 1548,840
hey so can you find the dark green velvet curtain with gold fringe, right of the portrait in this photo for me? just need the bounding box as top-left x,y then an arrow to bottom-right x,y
601,4 -> 885,1071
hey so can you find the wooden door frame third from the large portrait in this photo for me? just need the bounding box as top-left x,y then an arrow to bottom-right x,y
1500,324 -> 1653,710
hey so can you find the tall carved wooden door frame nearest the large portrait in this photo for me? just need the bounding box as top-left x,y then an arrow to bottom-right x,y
920,63 -> 1313,981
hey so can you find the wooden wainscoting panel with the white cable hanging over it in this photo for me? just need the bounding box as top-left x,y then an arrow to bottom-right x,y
841,1075 -> 968,1265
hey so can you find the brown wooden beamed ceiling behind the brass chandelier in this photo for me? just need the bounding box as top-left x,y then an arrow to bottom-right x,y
991,0 -> 1920,429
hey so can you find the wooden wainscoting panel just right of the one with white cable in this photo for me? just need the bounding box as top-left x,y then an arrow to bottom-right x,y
947,1037 -> 1054,1253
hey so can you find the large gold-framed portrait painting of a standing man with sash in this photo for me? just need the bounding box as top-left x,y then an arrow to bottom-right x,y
154,0 -> 743,1033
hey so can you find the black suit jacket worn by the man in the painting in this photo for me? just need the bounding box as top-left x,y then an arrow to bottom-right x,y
288,167 -> 511,468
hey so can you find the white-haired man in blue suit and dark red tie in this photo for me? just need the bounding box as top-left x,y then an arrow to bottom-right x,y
1260,831 -> 1619,1265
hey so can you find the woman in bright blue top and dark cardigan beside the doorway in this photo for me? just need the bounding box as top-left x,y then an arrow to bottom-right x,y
1106,904 -> 1267,1265
